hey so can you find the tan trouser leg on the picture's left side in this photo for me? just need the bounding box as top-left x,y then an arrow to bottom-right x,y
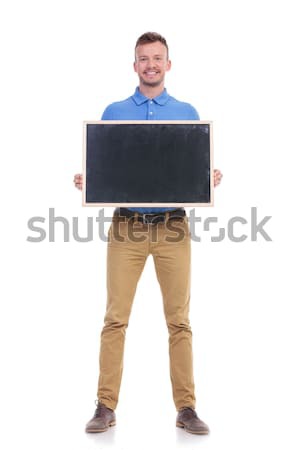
98,220 -> 148,409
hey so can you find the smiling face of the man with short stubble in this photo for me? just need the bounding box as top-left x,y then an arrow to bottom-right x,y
134,42 -> 171,87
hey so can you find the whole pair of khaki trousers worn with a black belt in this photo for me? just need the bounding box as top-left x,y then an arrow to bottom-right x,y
98,215 -> 195,410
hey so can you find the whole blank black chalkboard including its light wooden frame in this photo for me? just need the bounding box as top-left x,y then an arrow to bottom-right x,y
83,120 -> 213,207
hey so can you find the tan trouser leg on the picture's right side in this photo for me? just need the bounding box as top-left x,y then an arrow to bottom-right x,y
151,220 -> 196,410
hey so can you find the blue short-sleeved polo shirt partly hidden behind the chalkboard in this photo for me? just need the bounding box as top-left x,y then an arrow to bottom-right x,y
101,87 -> 200,213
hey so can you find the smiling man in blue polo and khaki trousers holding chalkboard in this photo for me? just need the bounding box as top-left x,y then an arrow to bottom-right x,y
74,33 -> 222,434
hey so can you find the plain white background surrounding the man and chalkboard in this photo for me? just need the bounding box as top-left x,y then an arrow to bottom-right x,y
0,0 -> 300,450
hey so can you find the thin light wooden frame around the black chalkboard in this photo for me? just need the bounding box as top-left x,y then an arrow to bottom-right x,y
82,120 -> 214,208
